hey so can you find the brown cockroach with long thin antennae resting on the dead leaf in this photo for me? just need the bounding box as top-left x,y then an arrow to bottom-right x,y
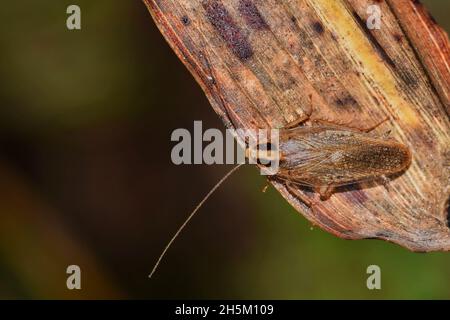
149,49 -> 411,278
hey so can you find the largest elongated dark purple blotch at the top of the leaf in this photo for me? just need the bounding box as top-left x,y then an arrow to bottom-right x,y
202,0 -> 253,61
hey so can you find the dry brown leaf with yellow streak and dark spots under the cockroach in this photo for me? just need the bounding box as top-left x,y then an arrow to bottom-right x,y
144,0 -> 450,251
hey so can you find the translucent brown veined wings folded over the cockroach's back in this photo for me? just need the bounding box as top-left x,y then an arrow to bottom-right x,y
278,126 -> 411,187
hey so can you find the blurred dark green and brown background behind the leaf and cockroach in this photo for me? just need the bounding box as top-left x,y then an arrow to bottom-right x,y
0,0 -> 450,299
